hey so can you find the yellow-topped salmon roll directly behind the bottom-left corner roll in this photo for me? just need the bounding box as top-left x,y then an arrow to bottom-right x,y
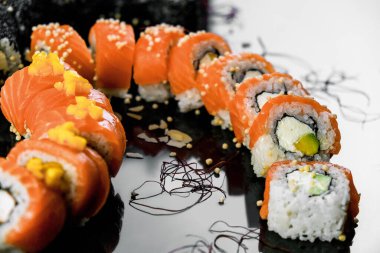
7,137 -> 109,221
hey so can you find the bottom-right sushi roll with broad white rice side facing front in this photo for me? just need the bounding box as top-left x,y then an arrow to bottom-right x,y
260,161 -> 360,242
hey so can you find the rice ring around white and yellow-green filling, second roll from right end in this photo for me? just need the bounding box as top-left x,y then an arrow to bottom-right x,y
251,102 -> 336,177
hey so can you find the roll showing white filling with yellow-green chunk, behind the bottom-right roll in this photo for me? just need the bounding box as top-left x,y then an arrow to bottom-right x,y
249,95 -> 340,177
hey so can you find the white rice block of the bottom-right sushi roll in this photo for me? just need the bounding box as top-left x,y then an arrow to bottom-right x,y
268,165 -> 350,242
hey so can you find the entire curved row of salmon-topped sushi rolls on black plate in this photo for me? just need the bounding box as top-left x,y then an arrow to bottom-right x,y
0,19 -> 360,252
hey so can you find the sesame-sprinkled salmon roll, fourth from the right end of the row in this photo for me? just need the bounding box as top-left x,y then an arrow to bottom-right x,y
197,53 -> 274,129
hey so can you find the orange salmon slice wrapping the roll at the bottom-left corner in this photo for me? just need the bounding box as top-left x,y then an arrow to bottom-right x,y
0,161 -> 66,252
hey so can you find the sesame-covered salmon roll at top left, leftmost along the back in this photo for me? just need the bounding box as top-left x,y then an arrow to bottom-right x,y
30,23 -> 95,81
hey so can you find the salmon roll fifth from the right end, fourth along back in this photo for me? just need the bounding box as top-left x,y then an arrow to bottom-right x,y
168,31 -> 231,112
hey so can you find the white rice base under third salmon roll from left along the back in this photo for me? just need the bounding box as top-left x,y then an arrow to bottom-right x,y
138,83 -> 170,103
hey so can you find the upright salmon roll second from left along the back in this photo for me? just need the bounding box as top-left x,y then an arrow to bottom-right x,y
88,19 -> 135,97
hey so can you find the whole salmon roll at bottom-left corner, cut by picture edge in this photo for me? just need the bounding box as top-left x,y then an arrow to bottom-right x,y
0,160 -> 66,252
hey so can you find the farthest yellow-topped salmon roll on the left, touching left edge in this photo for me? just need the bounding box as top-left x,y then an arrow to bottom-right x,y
1,52 -> 65,137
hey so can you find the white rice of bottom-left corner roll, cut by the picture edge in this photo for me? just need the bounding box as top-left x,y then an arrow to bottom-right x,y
0,169 -> 30,252
